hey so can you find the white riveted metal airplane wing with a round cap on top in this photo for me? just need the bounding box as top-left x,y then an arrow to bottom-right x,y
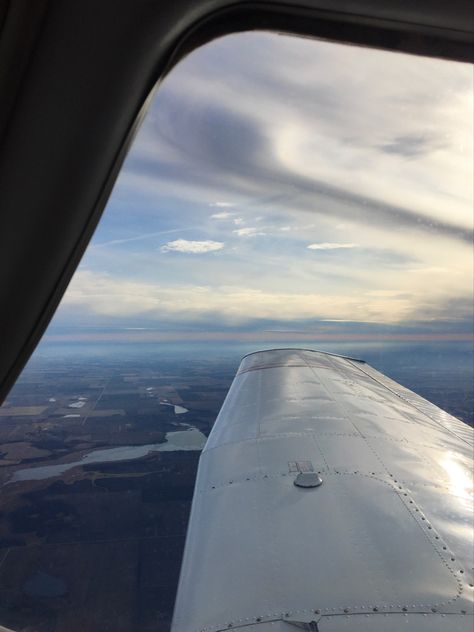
172,349 -> 473,632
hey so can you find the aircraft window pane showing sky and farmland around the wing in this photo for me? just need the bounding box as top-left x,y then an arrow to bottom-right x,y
0,32 -> 474,632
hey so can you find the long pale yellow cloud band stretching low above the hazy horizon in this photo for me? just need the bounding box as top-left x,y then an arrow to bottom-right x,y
61,270 -> 472,326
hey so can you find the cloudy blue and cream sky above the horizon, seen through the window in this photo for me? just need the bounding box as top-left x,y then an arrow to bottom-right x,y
45,32 -> 474,339
